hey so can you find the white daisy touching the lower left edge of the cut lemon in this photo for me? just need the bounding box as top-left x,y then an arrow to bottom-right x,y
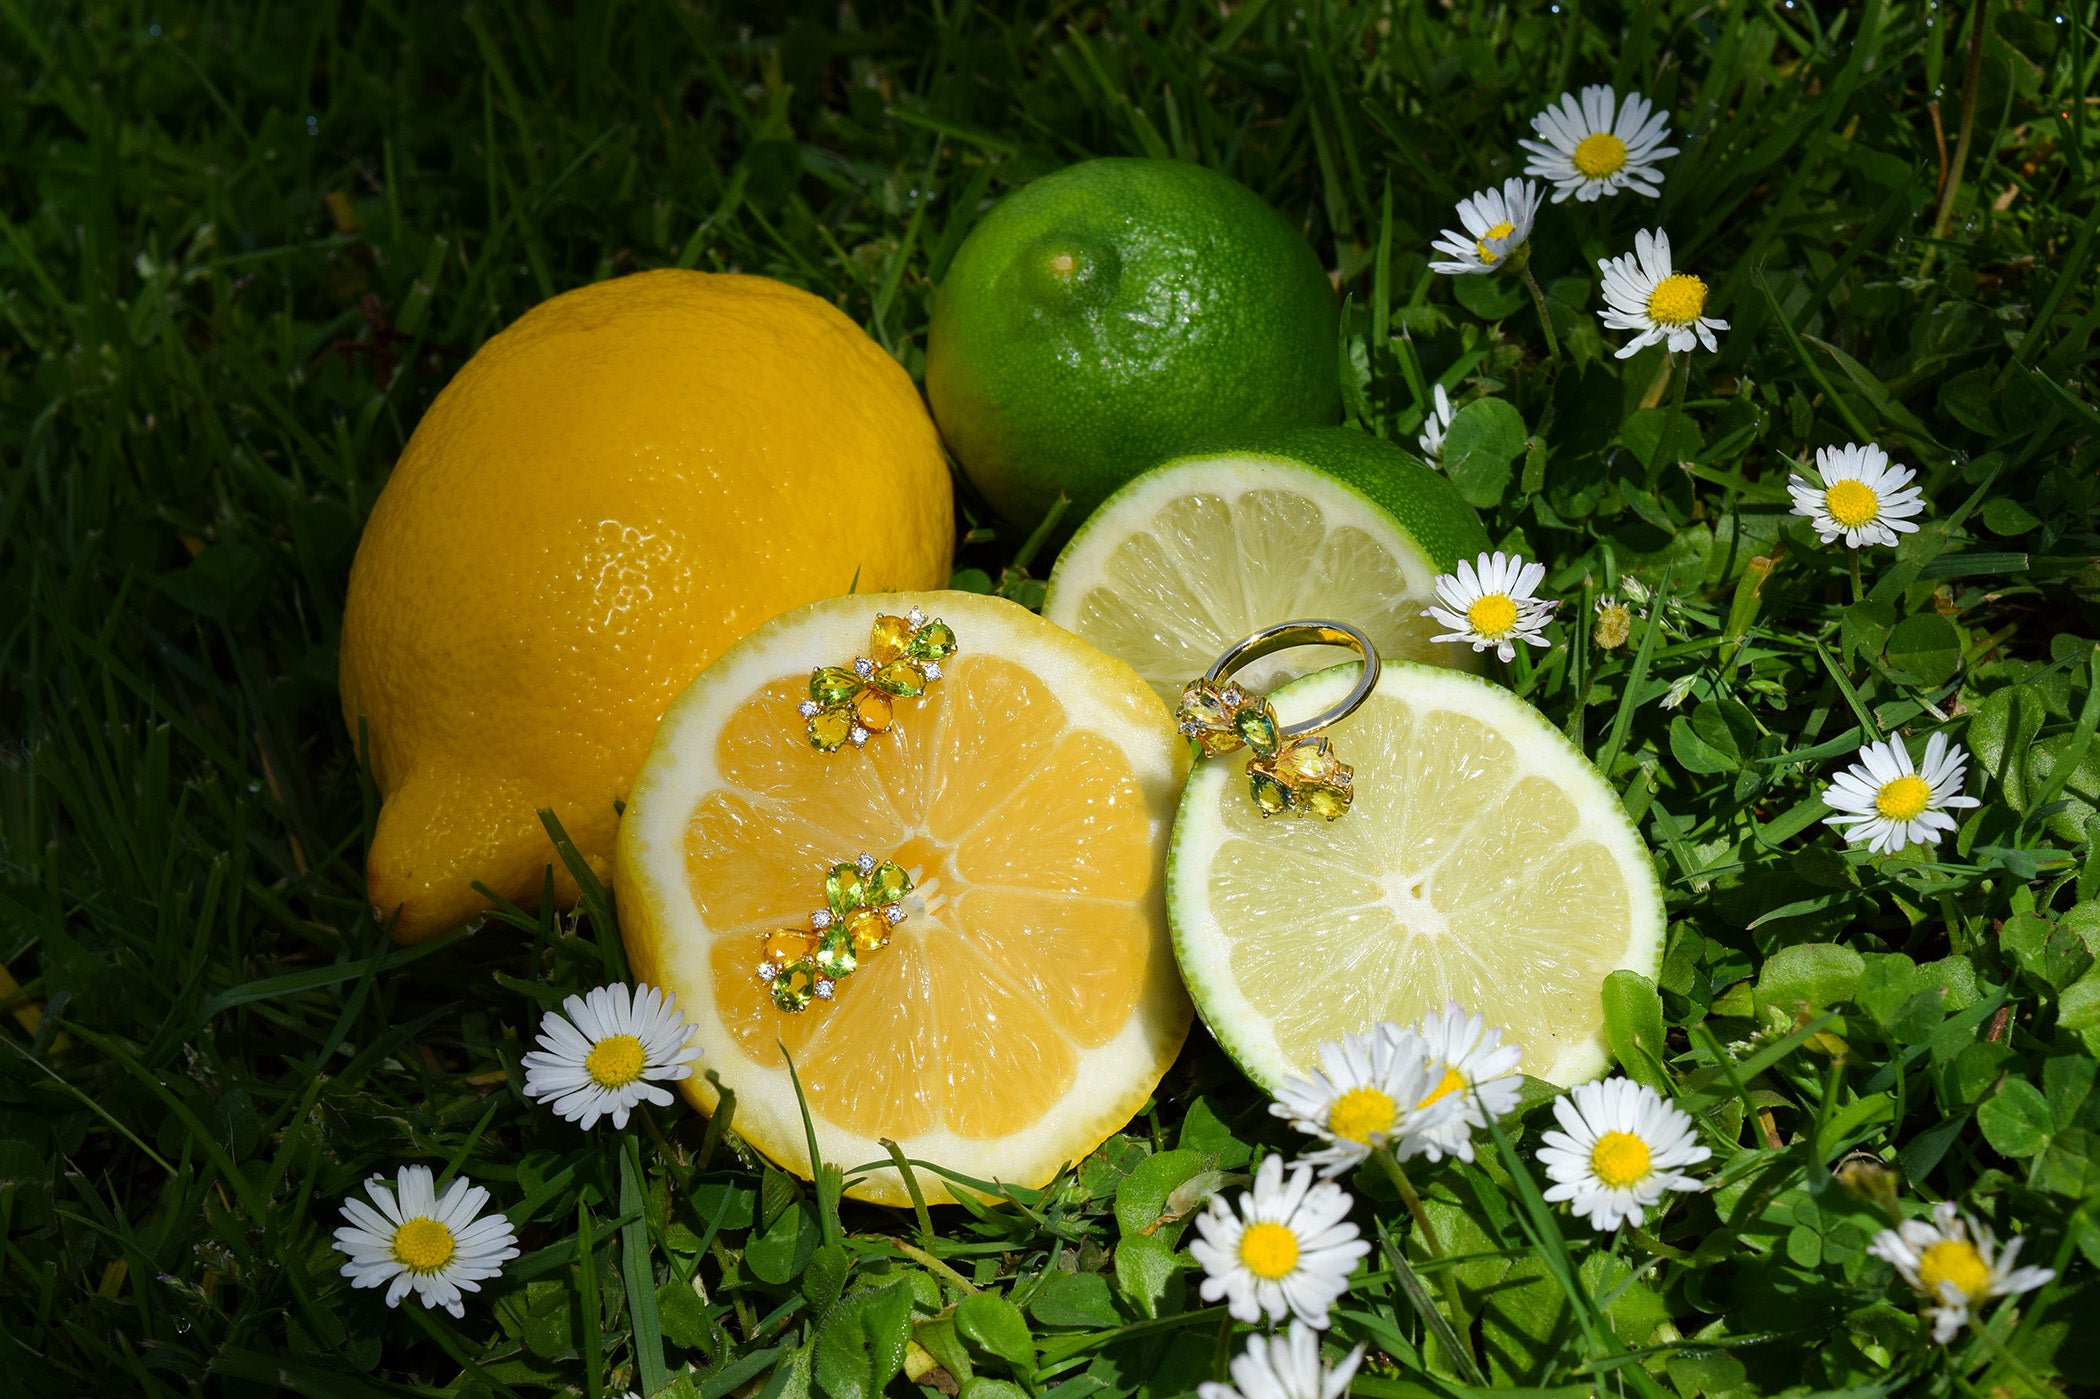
519,983 -> 699,1132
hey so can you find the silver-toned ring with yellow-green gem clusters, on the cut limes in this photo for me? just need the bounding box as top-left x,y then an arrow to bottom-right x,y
1176,618 -> 1380,821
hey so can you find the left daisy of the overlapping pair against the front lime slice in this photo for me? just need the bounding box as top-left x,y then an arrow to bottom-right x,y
1268,1025 -> 1464,1181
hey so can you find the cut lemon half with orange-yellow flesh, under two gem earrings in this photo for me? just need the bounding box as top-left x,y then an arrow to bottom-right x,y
617,592 -> 1191,1204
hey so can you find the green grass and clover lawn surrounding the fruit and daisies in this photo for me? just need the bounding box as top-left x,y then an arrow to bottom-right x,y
0,0 -> 2100,1399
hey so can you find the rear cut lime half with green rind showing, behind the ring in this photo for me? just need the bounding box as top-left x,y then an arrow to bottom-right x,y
1044,429 -> 1487,704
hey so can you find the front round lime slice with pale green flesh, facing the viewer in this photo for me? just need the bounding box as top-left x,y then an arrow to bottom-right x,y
1168,664 -> 1663,1090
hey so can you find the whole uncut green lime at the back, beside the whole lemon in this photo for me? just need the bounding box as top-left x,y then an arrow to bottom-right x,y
926,158 -> 1342,527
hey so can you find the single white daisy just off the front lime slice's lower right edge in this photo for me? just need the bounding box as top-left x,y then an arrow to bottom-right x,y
1539,1078 -> 1714,1233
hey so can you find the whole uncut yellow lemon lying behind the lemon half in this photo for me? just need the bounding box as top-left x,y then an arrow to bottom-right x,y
340,271 -> 956,941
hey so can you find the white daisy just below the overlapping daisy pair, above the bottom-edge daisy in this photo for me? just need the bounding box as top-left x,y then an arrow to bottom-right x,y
1189,1155 -> 1371,1330
